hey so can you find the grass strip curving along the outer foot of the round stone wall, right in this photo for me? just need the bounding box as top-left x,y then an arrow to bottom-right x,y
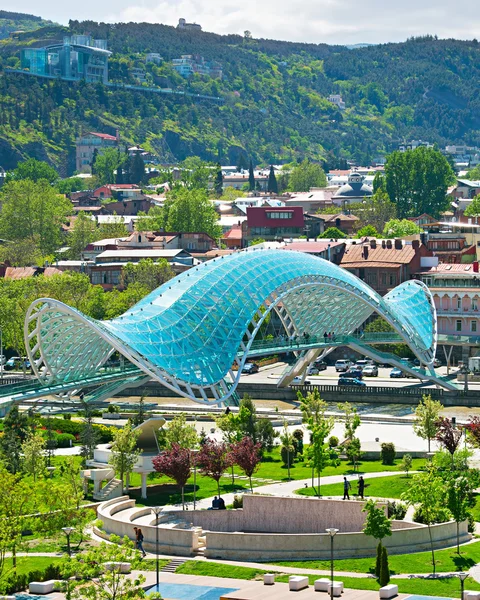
272,541 -> 480,575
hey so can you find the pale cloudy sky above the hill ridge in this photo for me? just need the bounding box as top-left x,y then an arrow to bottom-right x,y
2,0 -> 480,44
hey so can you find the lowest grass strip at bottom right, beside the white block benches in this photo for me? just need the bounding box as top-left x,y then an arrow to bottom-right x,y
275,573 -> 466,598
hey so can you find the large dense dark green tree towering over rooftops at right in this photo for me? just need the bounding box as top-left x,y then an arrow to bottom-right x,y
385,146 -> 455,219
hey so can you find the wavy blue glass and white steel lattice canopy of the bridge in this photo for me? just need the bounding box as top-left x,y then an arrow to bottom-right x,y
25,249 -> 436,402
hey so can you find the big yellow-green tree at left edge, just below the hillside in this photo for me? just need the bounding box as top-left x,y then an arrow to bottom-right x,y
0,179 -> 73,256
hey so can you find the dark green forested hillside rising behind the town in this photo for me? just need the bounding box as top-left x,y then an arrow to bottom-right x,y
0,15 -> 480,174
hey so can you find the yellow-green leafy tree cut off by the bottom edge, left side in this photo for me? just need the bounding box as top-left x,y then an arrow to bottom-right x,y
62,535 -> 145,600
